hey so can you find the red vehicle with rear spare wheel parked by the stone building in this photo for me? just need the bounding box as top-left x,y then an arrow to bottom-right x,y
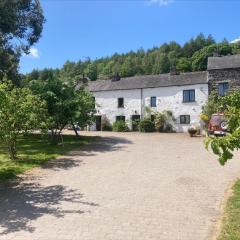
208,113 -> 228,136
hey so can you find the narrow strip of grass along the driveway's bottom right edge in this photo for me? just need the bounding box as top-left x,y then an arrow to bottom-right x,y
218,180 -> 240,240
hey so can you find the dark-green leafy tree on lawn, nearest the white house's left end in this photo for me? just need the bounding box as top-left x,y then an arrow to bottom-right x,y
28,75 -> 95,144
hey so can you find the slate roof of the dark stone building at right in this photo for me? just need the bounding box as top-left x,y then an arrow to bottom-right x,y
208,54 -> 240,70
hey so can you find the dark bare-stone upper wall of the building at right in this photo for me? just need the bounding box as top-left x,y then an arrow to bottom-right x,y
208,68 -> 240,93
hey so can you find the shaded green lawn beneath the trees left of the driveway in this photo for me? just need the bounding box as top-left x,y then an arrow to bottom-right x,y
0,134 -> 93,181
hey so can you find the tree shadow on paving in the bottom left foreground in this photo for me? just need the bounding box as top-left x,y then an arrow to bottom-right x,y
0,181 -> 99,234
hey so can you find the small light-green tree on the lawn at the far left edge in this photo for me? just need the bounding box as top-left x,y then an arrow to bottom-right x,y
0,83 -> 46,160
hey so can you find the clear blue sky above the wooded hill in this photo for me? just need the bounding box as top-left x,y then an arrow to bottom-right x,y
20,0 -> 240,73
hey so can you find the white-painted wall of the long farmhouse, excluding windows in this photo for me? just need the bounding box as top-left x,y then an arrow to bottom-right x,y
91,84 -> 208,132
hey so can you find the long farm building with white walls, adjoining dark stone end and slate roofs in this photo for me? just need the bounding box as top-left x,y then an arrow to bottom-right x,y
88,55 -> 240,132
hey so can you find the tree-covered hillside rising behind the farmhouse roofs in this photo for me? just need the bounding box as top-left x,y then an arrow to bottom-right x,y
24,34 -> 240,82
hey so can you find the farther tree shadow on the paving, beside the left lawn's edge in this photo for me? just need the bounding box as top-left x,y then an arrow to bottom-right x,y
42,136 -> 132,170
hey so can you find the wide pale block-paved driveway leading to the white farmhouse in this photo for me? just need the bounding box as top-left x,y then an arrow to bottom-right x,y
0,133 -> 240,240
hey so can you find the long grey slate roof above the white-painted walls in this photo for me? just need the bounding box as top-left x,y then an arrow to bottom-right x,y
88,72 -> 208,92
